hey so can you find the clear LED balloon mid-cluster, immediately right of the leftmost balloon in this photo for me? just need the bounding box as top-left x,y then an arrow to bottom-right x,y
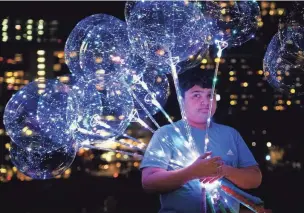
67,80 -> 134,143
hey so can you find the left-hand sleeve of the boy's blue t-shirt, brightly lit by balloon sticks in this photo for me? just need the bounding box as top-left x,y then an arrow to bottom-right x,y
140,128 -> 172,170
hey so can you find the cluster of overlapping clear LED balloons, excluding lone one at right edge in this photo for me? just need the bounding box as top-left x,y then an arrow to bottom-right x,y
4,1 -> 259,179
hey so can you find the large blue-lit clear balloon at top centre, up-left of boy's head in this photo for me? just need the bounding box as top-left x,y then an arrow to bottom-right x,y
125,1 -> 208,64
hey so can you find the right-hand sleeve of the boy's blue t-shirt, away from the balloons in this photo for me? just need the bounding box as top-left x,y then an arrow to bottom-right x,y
235,130 -> 258,168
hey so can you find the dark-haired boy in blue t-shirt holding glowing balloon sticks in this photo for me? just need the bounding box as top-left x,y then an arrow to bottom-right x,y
141,67 -> 262,213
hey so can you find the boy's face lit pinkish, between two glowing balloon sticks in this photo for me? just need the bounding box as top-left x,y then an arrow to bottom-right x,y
184,85 -> 216,123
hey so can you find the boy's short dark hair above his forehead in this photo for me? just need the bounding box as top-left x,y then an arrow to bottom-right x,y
178,66 -> 214,97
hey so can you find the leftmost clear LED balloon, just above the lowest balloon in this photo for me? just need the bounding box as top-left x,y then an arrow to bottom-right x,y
3,80 -> 75,151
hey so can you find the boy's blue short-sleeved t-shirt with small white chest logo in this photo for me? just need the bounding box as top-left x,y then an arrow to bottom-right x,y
140,120 -> 257,213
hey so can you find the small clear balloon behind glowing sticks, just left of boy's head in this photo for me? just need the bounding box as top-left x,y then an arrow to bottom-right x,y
132,65 -> 170,118
